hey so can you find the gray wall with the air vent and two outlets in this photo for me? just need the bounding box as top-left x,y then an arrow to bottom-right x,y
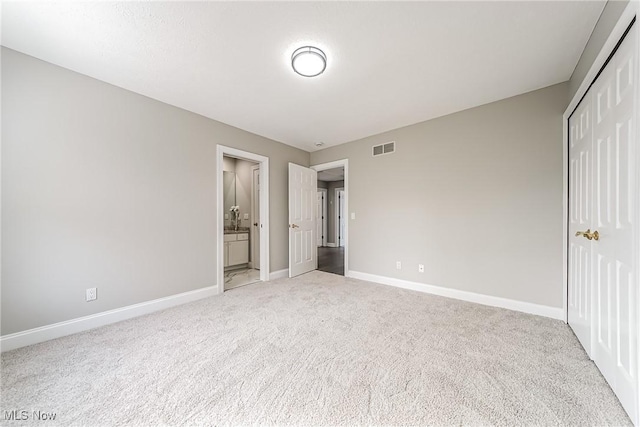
311,83 -> 569,307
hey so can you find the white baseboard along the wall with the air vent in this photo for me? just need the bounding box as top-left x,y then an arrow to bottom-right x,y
347,270 -> 564,320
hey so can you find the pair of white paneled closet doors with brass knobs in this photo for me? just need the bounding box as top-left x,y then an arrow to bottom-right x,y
568,25 -> 640,424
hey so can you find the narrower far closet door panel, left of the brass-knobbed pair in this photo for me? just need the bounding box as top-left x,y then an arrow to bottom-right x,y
568,97 -> 592,355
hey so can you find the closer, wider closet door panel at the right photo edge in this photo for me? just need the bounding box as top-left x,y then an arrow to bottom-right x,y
591,25 -> 638,422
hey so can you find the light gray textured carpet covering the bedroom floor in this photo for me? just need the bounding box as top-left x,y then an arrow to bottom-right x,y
0,272 -> 630,426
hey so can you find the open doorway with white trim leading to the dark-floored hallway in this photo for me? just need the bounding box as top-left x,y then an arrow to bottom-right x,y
312,160 -> 348,276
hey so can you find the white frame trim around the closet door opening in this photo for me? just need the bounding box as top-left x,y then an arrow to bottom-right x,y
562,1 -> 640,320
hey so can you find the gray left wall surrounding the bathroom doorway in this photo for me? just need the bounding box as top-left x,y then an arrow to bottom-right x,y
1,48 -> 309,335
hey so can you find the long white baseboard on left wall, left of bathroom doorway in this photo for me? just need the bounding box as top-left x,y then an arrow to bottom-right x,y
0,286 -> 218,351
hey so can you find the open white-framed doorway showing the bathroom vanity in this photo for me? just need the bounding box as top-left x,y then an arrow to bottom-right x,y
217,145 -> 269,292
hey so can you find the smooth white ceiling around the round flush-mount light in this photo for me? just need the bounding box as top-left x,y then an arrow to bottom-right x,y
2,1 -> 605,151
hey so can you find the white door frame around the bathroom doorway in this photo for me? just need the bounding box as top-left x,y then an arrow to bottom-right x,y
216,144 -> 269,294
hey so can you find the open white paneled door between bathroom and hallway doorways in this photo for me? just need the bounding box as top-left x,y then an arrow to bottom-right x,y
289,163 -> 318,277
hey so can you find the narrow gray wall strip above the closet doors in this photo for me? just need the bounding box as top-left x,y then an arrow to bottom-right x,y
569,0 -> 629,99
